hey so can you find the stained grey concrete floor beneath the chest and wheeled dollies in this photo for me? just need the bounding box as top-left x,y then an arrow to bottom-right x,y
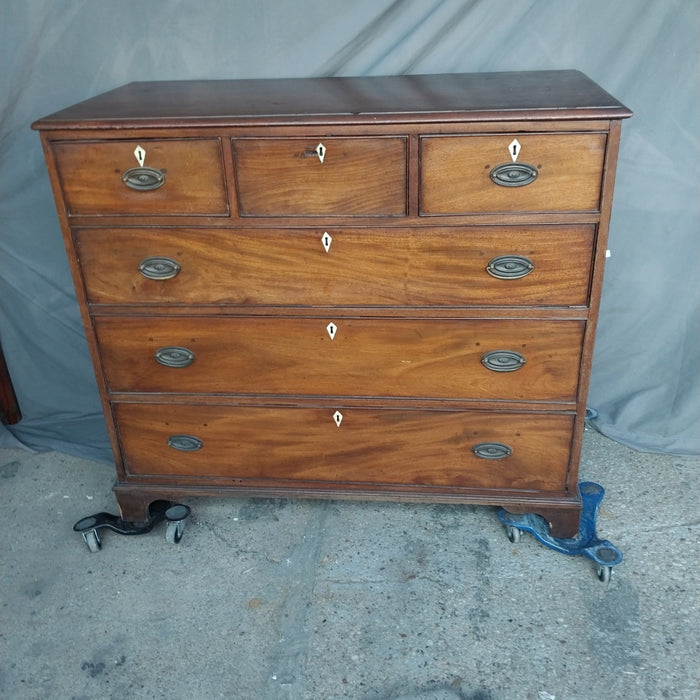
0,432 -> 700,700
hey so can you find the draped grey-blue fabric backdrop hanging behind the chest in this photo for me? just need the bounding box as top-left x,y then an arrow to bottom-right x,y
0,0 -> 700,460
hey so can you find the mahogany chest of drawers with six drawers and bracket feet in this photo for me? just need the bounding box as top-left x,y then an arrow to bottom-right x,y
34,71 -> 630,536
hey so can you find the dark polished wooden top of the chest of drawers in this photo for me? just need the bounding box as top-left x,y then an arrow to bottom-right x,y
35,70 -> 632,129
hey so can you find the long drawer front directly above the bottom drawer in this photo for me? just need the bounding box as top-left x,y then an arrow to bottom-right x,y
95,316 -> 584,402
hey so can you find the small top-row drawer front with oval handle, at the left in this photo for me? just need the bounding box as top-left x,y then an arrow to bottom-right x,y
54,138 -> 228,216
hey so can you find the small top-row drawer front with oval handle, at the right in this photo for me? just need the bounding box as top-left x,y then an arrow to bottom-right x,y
420,133 -> 606,215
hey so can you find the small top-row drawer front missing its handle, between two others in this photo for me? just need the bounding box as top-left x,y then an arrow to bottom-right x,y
233,137 -> 407,216
